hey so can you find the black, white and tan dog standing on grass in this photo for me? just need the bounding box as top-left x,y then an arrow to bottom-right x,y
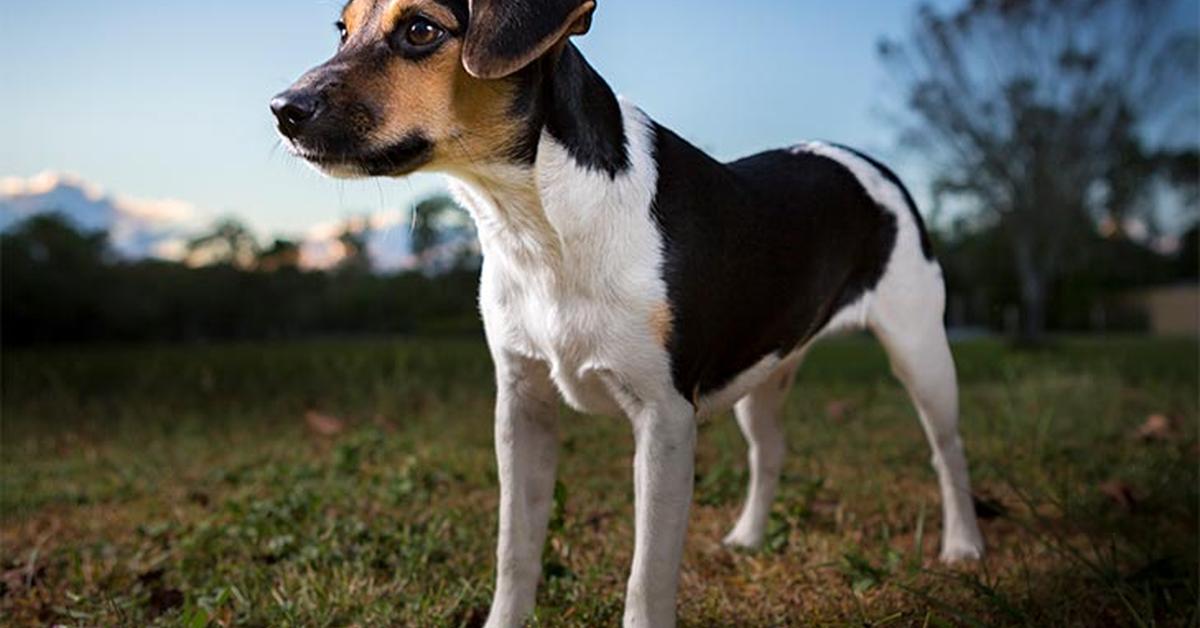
271,0 -> 983,627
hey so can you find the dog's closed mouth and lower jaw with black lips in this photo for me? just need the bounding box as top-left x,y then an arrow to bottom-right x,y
287,133 -> 433,177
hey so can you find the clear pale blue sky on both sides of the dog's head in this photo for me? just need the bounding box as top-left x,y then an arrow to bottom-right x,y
0,0 -> 958,233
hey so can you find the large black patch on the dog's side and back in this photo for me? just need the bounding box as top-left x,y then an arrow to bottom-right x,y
652,130 -> 896,400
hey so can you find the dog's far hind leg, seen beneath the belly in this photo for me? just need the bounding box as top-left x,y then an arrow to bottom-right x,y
725,364 -> 796,549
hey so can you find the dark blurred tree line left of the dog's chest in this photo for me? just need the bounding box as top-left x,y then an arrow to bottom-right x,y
0,206 -> 479,346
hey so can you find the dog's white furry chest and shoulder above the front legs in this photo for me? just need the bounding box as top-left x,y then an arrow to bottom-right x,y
456,107 -> 670,413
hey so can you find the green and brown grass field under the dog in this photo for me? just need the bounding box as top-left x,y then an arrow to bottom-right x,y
0,339 -> 1200,627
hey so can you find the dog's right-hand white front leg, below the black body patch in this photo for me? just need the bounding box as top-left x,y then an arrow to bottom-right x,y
625,397 -> 696,628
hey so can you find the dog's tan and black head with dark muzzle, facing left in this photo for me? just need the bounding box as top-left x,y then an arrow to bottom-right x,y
271,0 -> 595,177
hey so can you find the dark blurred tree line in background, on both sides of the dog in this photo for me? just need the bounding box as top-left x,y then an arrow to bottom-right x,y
0,200 -> 1200,346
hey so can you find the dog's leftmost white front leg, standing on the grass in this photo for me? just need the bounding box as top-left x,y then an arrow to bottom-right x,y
487,355 -> 558,628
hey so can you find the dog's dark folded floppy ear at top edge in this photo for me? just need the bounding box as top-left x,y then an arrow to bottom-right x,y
462,0 -> 596,78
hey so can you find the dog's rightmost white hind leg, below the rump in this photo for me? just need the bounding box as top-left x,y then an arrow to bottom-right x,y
871,267 -> 983,562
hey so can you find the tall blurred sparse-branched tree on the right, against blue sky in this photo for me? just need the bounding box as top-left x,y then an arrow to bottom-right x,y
880,0 -> 1198,341
